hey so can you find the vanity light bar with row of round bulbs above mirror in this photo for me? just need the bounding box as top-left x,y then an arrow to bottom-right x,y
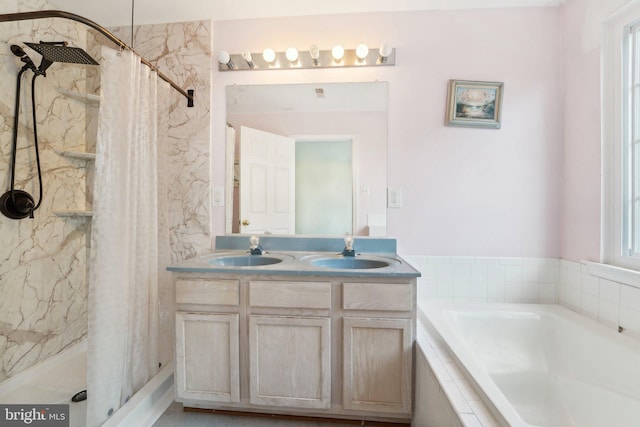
218,45 -> 396,71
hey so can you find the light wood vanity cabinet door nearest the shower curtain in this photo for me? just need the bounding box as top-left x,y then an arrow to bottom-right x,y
176,312 -> 240,402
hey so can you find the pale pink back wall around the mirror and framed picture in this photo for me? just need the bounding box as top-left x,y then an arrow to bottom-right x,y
212,8 -> 563,257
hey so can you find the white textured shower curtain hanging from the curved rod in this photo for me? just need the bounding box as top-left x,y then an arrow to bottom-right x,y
87,48 -> 165,427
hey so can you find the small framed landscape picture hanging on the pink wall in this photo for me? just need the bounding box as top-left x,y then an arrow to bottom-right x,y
446,80 -> 504,129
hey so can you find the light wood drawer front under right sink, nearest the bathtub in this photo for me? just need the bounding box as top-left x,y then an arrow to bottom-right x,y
342,283 -> 413,311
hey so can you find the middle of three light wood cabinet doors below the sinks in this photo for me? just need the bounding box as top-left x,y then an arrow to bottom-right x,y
249,316 -> 331,408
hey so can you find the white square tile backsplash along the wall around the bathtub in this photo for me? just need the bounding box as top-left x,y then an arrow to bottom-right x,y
403,255 -> 640,339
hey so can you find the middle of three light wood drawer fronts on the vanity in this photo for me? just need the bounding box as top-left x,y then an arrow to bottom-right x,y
249,281 -> 331,310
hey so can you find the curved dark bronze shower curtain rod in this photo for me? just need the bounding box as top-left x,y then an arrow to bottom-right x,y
0,10 -> 194,107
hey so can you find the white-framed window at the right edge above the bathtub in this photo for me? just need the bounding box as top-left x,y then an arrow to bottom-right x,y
602,8 -> 640,270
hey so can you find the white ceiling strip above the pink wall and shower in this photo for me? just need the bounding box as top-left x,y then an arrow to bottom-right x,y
50,0 -> 565,27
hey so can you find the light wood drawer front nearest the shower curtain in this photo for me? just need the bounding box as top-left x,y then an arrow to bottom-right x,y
176,279 -> 240,305
